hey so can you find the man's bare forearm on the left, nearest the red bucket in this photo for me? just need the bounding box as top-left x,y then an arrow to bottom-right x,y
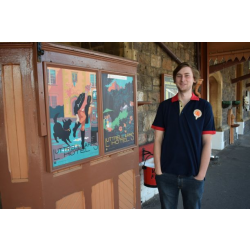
154,130 -> 164,175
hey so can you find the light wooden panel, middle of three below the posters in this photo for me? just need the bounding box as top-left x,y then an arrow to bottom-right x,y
91,179 -> 114,209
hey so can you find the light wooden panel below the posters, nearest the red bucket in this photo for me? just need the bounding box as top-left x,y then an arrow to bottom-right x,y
118,170 -> 135,209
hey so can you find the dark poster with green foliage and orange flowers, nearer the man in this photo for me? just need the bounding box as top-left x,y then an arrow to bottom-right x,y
102,73 -> 135,153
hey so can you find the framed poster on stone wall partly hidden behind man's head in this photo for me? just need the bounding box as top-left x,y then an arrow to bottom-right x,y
161,74 -> 178,102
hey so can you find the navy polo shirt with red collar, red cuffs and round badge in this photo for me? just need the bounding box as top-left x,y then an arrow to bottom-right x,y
151,94 -> 216,176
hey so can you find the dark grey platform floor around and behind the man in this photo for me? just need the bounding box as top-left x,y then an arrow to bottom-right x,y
142,133 -> 250,209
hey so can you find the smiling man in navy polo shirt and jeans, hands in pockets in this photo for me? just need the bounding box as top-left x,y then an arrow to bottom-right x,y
152,62 -> 215,209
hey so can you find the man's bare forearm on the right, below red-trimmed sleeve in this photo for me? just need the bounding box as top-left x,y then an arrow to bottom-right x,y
195,134 -> 212,180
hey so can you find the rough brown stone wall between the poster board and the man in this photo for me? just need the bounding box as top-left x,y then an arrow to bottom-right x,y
81,42 -> 196,145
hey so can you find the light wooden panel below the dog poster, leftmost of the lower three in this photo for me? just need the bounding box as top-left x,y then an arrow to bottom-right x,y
56,191 -> 85,209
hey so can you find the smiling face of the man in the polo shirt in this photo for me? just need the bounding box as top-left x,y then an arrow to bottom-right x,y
175,67 -> 194,93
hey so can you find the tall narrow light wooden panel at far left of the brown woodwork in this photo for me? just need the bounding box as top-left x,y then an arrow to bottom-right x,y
3,65 -> 28,181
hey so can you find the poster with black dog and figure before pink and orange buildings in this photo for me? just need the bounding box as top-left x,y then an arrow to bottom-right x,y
47,67 -> 99,168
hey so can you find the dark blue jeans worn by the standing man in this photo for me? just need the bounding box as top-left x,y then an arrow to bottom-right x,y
155,173 -> 204,209
